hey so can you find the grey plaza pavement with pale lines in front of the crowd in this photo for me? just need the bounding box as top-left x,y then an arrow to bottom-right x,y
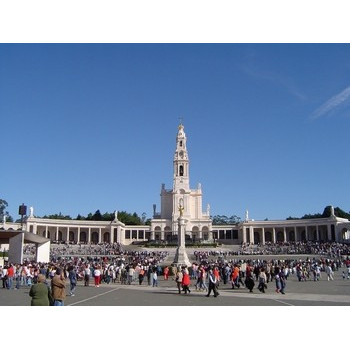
0,252 -> 350,306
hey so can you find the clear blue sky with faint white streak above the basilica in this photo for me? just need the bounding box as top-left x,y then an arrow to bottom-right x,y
0,44 -> 350,220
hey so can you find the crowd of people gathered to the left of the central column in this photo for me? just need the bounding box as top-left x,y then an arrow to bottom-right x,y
0,244 -> 169,305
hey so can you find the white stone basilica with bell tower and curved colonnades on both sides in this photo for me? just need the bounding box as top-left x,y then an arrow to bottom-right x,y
0,123 -> 350,245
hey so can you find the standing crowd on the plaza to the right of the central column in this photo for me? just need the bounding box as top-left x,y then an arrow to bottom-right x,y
187,255 -> 350,294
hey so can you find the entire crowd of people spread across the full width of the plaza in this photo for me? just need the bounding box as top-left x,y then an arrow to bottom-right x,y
0,242 -> 350,306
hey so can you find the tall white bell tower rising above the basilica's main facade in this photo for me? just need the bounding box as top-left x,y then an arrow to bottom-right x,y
173,123 -> 190,192
